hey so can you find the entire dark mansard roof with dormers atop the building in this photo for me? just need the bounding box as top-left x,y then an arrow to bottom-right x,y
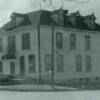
3,9 -> 100,31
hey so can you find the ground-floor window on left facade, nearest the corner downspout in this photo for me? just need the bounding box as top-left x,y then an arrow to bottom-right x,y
29,55 -> 35,73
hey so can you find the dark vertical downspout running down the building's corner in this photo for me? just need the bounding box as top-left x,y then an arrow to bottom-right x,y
38,25 -> 41,83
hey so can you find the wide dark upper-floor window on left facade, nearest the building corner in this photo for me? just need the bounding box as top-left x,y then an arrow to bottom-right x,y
22,33 -> 30,50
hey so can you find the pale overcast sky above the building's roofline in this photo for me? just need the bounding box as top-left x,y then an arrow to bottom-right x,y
0,0 -> 100,26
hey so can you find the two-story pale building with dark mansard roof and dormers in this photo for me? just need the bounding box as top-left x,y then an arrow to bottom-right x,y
0,9 -> 100,81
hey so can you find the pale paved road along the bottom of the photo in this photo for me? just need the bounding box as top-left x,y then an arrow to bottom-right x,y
0,91 -> 100,100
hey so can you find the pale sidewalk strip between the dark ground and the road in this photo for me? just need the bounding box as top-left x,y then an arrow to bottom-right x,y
0,85 -> 78,92
